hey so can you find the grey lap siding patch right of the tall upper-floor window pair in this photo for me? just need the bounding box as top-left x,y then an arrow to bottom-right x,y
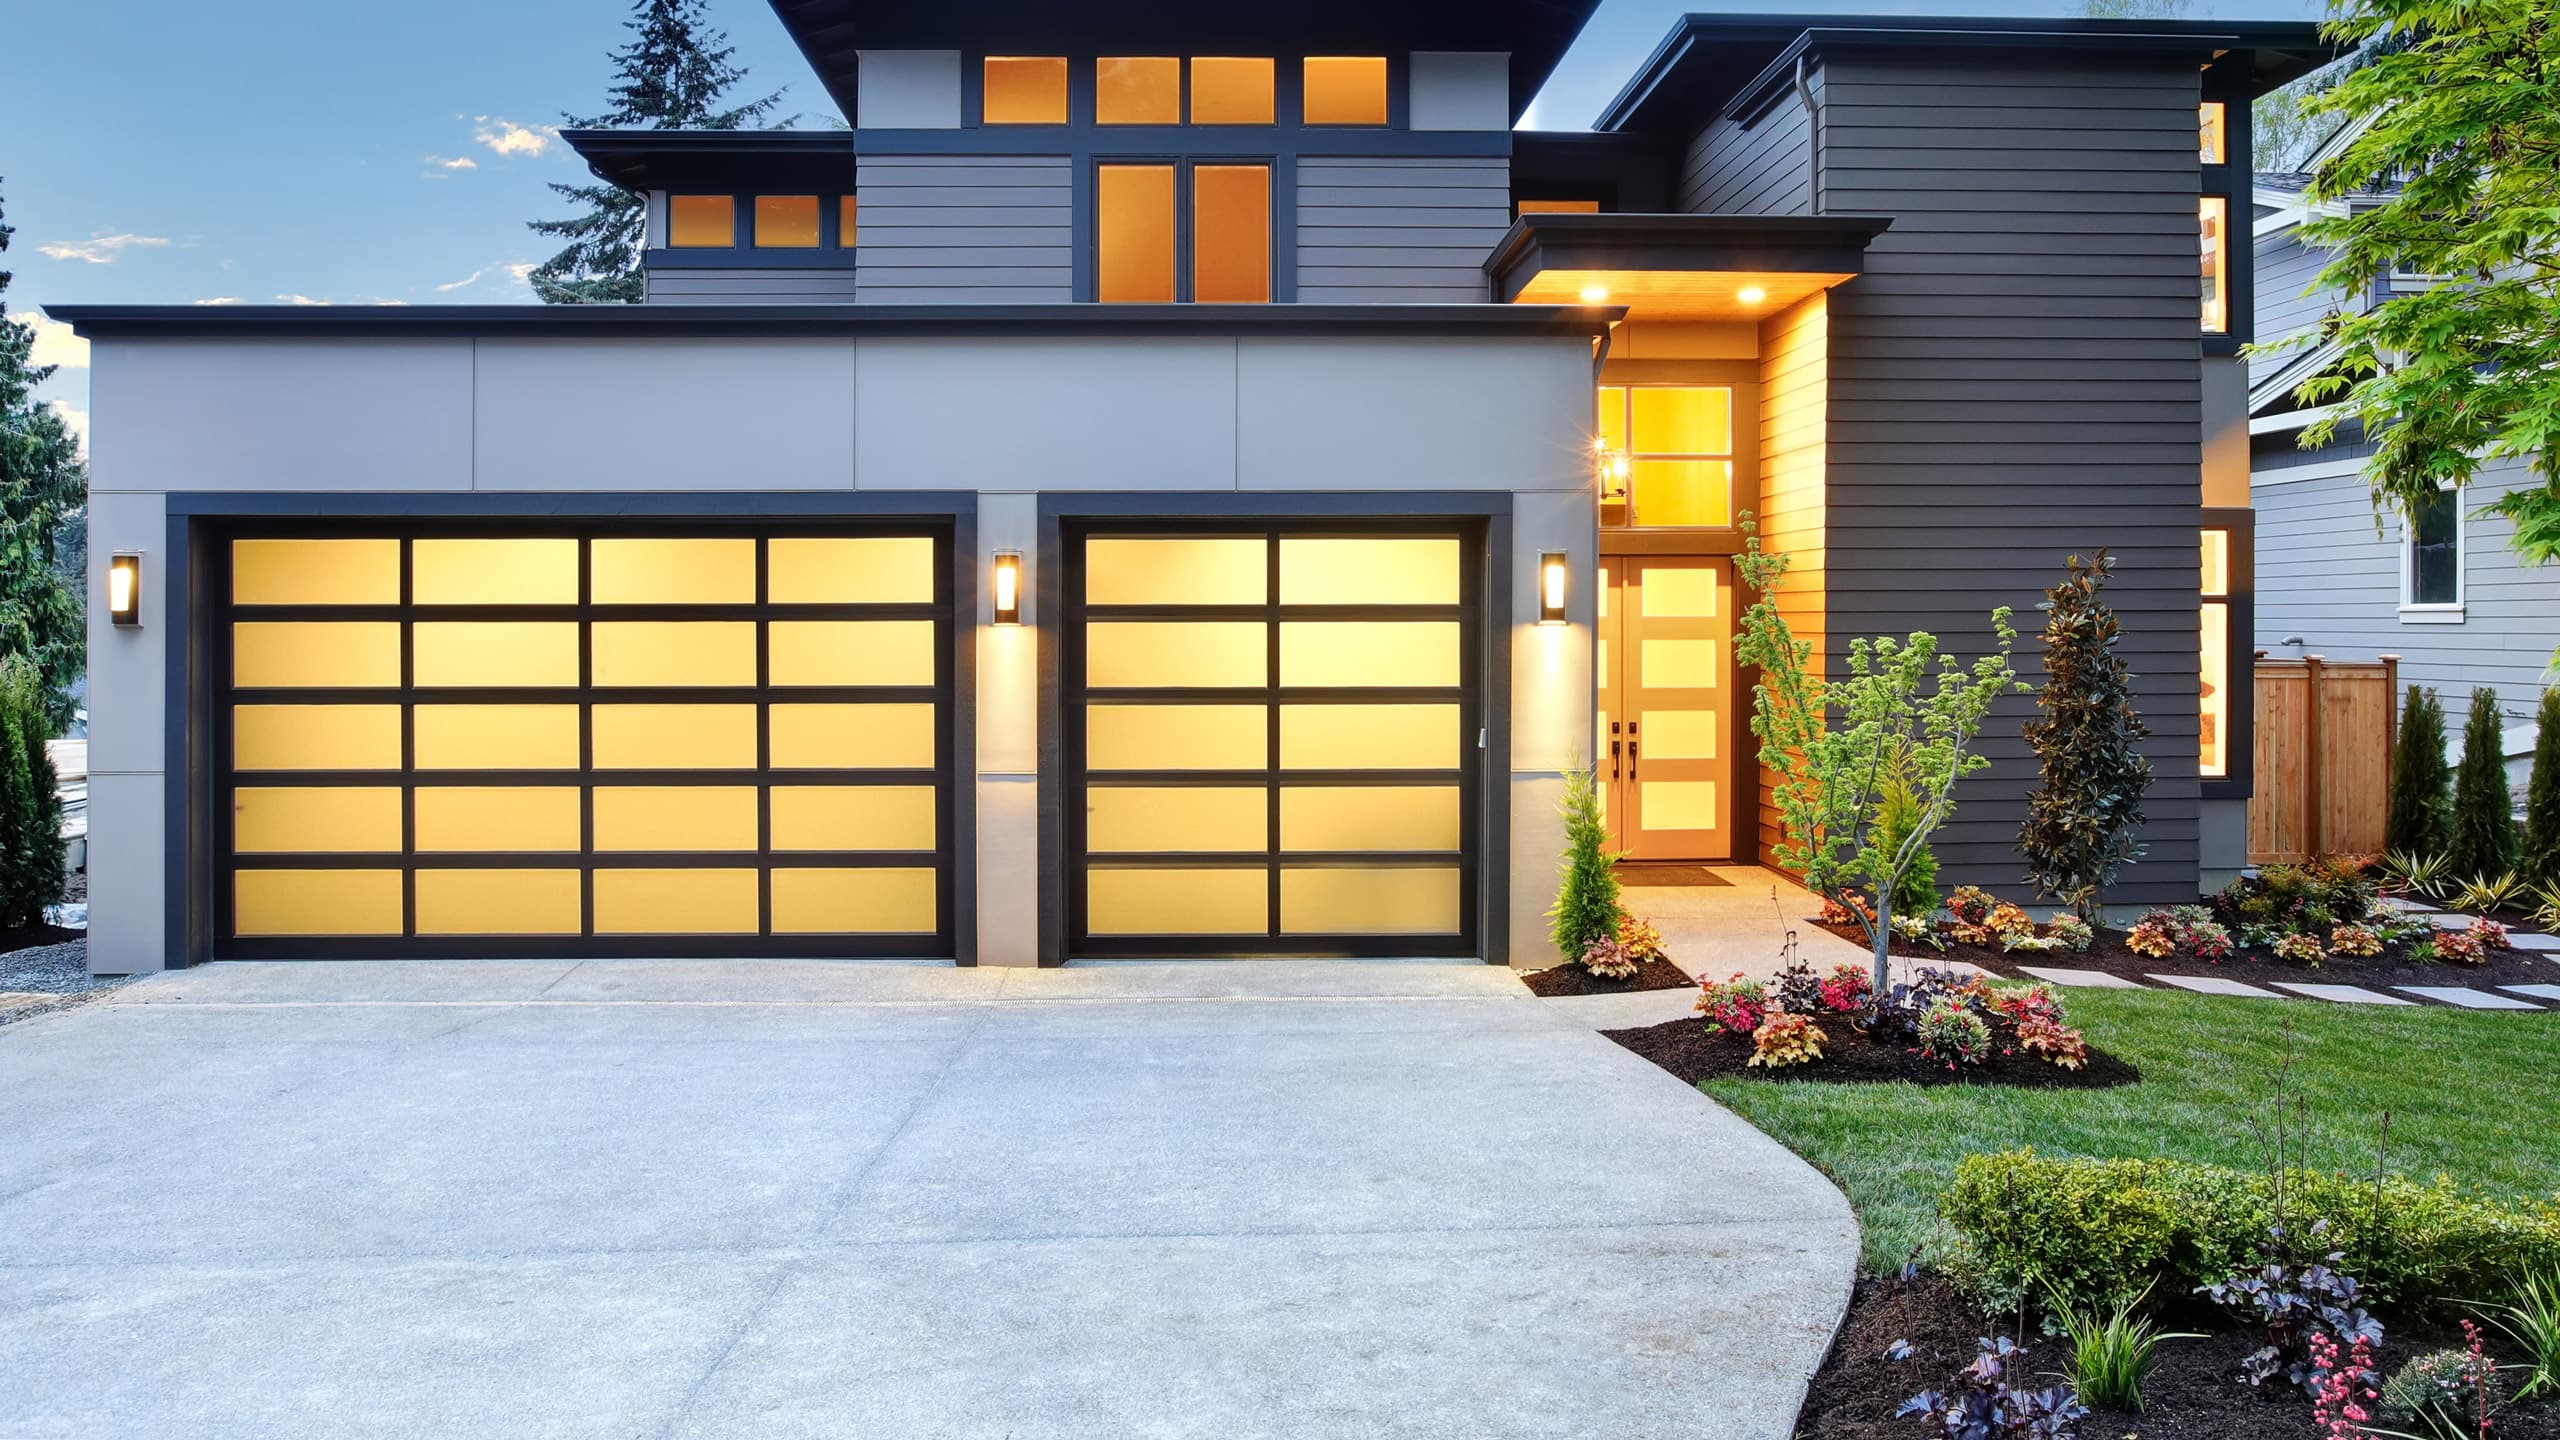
1298,156 -> 1510,305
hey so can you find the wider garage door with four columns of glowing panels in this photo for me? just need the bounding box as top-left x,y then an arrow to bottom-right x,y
212,525 -> 952,958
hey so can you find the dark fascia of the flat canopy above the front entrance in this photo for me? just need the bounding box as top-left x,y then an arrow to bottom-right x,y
1485,215 -> 1892,300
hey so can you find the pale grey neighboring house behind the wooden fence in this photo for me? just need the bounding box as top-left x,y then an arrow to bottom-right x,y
2250,152 -> 2560,794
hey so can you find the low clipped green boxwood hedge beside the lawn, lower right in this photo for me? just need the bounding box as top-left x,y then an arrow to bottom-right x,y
1938,1150 -> 2560,1309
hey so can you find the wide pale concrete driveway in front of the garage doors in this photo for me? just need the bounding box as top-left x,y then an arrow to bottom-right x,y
0,961 -> 1856,1440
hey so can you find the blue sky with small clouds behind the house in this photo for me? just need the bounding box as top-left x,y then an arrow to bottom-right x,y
0,0 -> 2317,445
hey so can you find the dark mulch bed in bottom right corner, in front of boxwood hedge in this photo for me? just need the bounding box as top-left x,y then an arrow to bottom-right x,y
1795,1273 -> 2560,1440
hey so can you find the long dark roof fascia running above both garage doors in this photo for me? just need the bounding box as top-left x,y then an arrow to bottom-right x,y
46,305 -> 1626,341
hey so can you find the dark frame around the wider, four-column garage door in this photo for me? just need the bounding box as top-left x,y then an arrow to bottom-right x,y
151,492 -> 980,966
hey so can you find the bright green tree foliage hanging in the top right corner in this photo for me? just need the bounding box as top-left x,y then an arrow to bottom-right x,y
2299,0 -> 2560,617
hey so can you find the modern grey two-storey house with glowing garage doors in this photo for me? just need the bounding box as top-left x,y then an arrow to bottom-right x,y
56,0 -> 2324,971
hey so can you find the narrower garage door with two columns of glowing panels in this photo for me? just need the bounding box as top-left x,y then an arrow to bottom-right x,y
1060,523 -> 1482,956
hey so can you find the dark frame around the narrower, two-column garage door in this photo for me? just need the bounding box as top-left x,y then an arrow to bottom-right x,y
1034,492 -> 1513,966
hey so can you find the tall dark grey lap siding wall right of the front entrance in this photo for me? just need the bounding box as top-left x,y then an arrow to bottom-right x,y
1823,56 -> 2202,904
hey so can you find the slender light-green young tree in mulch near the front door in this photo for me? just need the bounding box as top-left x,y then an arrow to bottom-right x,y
1733,518 -> 2025,1004
